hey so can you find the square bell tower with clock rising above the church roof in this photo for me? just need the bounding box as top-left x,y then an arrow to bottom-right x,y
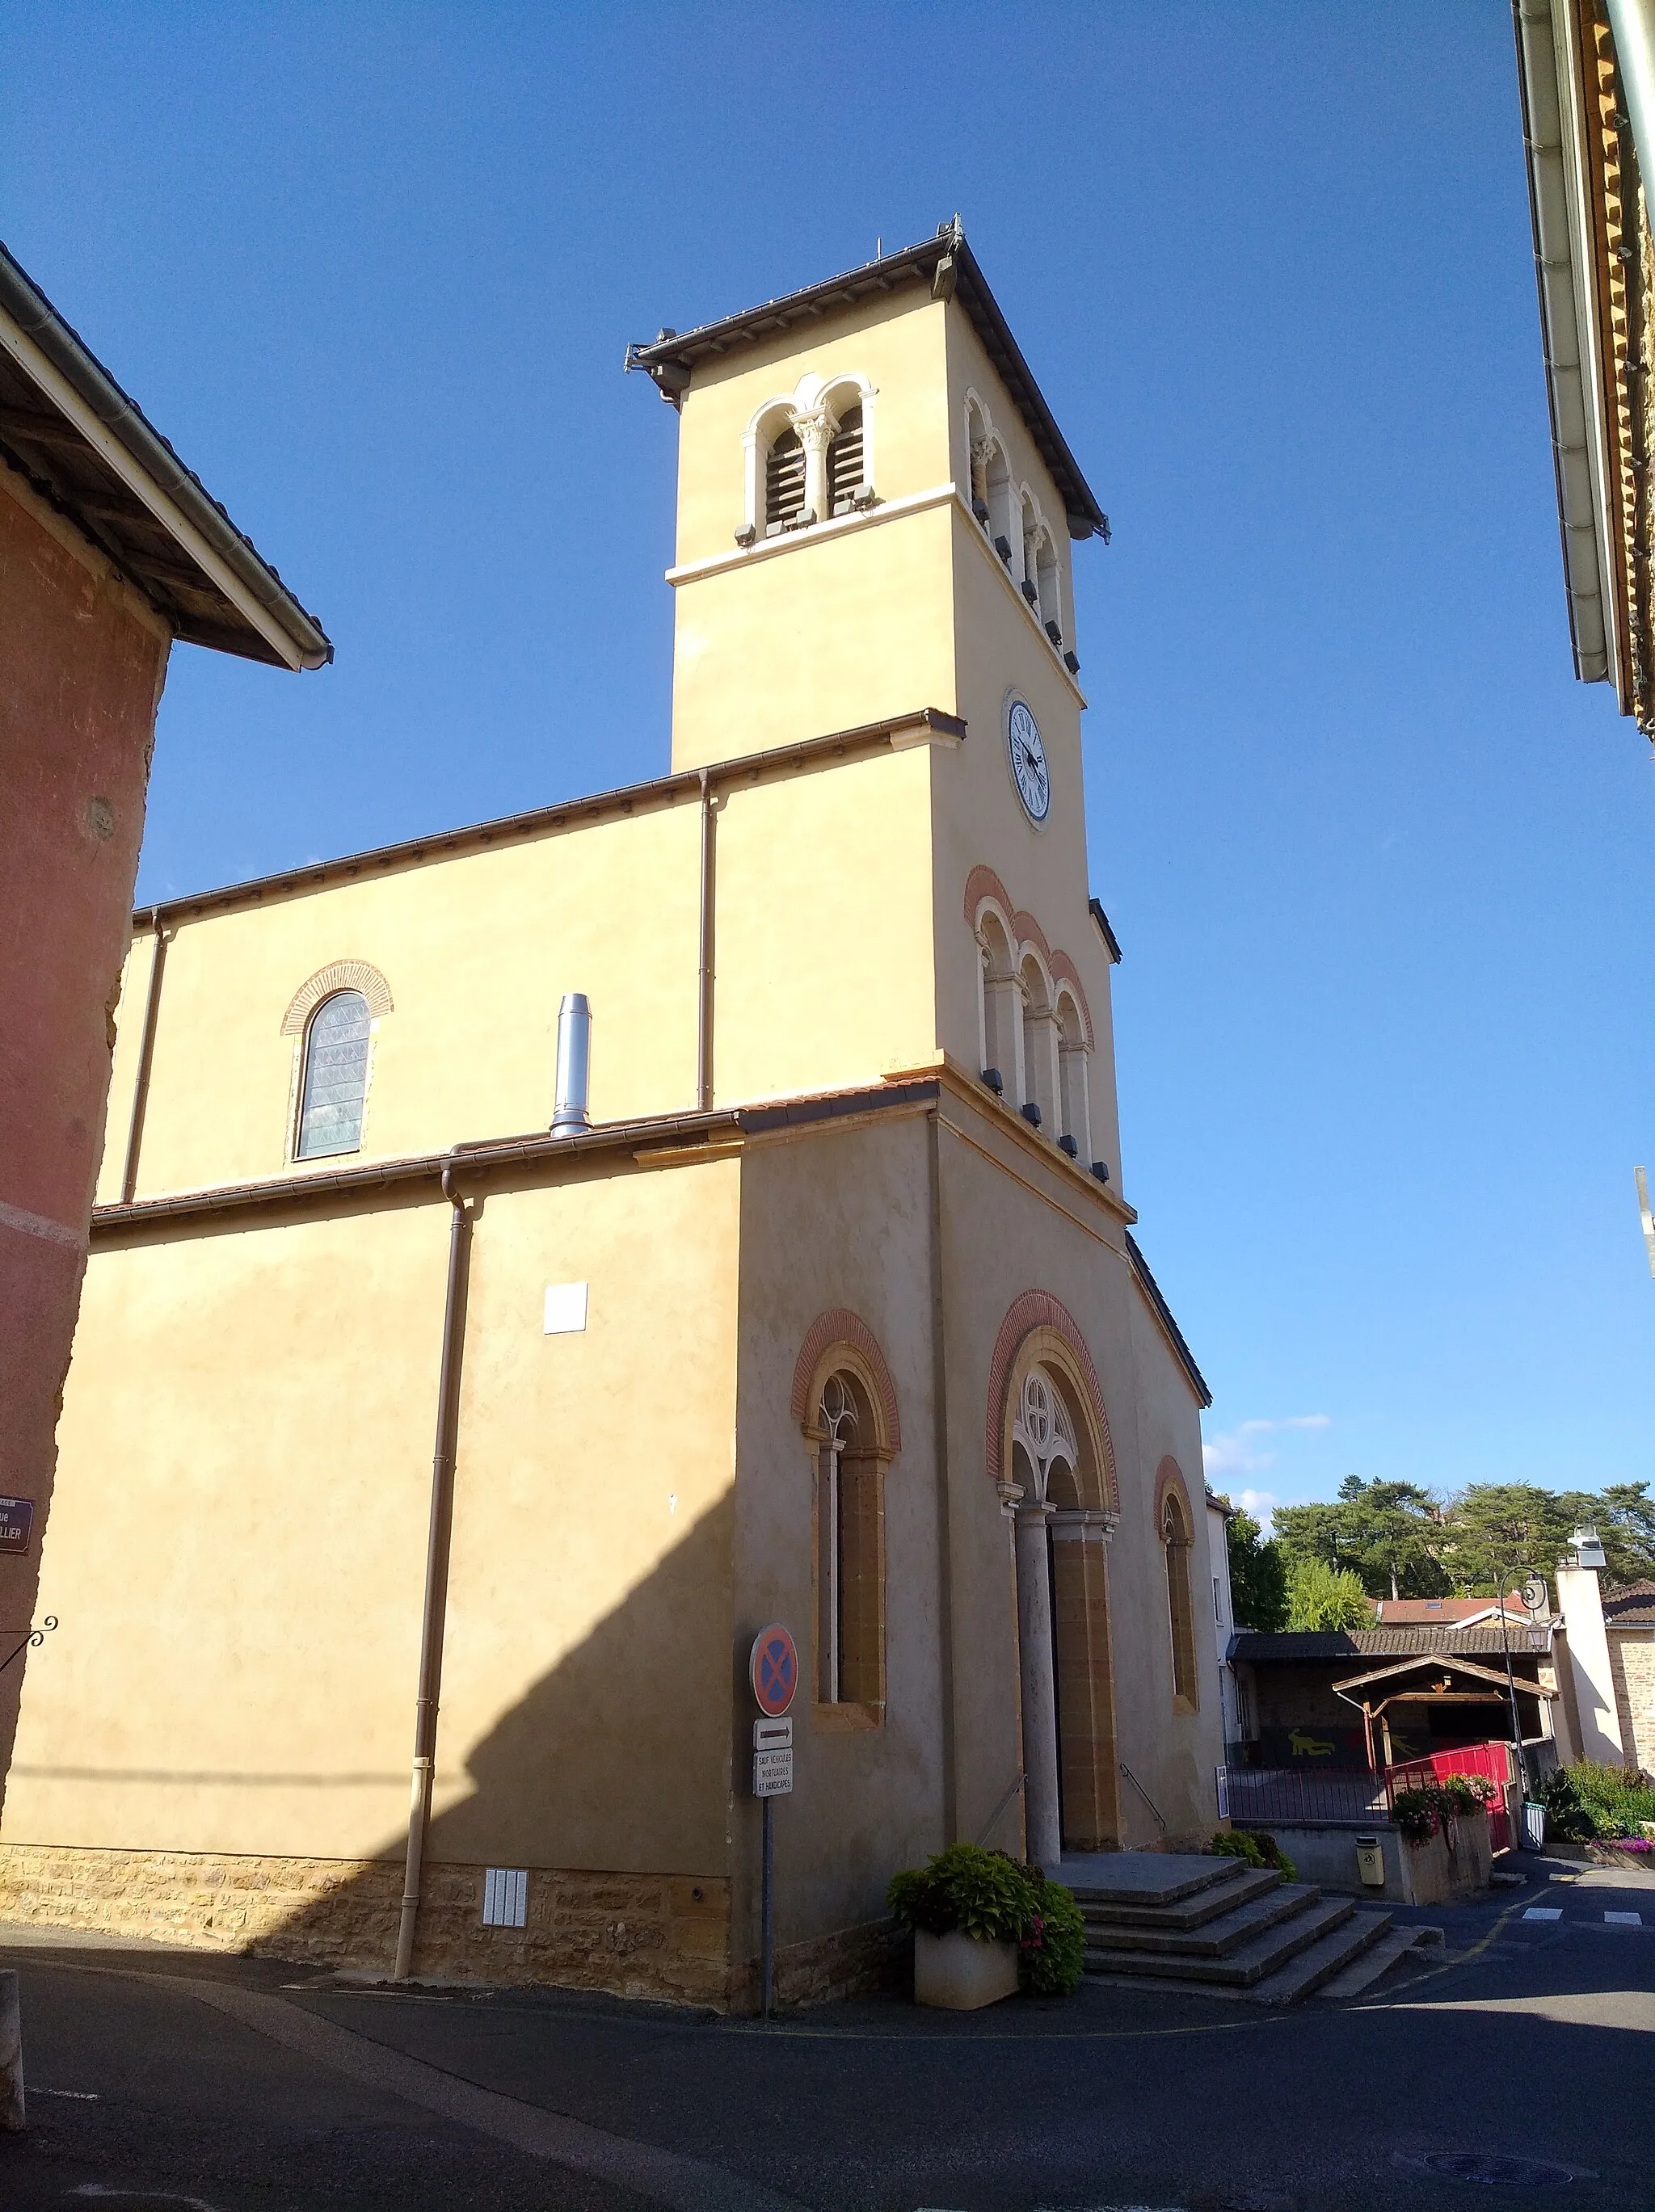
629,219 -> 1115,1172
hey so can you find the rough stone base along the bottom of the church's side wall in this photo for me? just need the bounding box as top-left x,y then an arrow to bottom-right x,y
0,1843 -> 730,2011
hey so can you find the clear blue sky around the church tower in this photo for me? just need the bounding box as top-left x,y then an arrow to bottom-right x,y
0,0 -> 1655,1502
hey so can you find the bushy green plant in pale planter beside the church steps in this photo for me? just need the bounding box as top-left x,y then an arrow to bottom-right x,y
887,1843 -> 1086,2013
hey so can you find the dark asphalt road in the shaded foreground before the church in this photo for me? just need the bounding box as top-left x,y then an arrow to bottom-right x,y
0,1862 -> 1655,2212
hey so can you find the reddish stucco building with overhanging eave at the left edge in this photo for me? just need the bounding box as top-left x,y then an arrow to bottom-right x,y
0,248 -> 332,1796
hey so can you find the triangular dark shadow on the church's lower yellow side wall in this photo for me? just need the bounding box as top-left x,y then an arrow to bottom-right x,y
263,1498 -> 735,2004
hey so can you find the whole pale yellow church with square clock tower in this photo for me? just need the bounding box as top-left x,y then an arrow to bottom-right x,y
0,221 -> 1223,2011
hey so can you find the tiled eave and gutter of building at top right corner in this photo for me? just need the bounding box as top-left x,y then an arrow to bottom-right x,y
1514,0 -> 1655,737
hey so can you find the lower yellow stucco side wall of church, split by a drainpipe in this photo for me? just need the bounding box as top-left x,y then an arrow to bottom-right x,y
0,1159 -> 739,1873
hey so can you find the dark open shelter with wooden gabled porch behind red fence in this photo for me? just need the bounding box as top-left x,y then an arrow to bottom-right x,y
1230,1615 -> 1562,1769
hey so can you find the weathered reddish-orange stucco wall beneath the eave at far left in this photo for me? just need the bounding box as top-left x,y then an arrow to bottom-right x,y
0,469 -> 168,1787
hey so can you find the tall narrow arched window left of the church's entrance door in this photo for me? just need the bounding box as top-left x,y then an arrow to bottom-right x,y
816,1369 -> 885,1705
